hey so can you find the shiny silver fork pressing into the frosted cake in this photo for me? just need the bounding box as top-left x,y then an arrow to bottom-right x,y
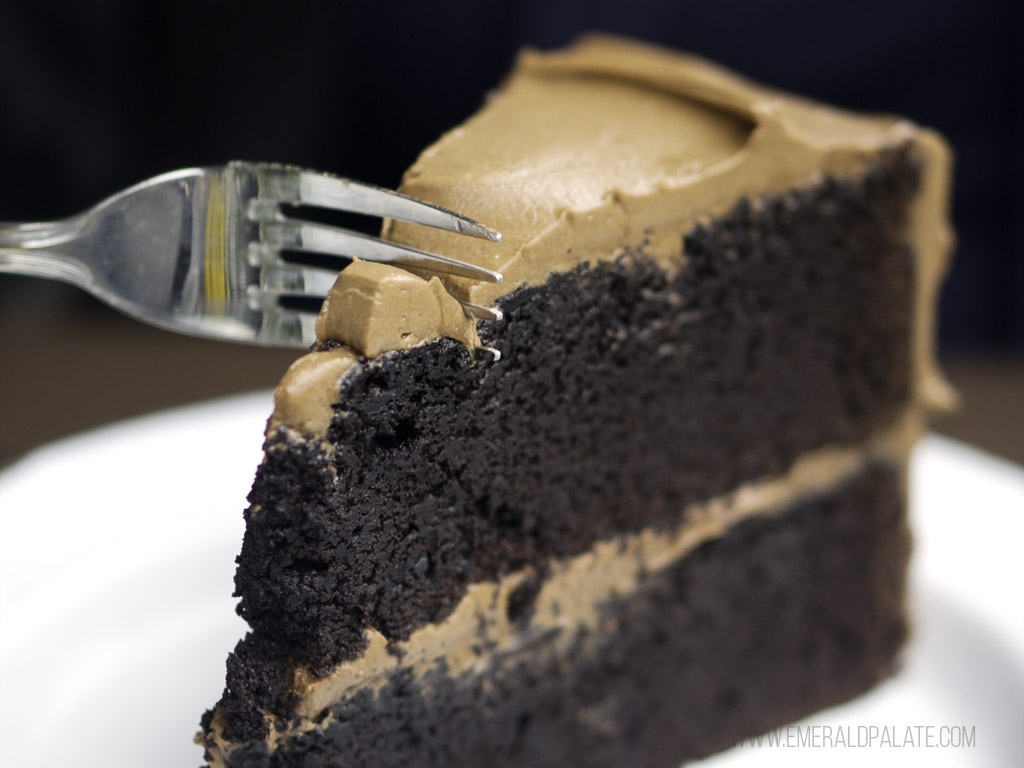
0,162 -> 502,347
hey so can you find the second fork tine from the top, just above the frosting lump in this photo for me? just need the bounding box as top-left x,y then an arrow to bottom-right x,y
260,218 -> 502,283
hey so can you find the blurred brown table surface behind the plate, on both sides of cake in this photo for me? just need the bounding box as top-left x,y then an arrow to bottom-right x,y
0,309 -> 1024,473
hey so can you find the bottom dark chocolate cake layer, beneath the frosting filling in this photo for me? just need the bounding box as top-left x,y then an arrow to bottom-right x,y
220,463 -> 909,768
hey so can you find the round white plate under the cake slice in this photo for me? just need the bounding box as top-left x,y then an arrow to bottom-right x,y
0,393 -> 1024,768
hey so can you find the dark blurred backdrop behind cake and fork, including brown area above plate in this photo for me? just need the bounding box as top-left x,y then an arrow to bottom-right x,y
0,0 -> 1024,463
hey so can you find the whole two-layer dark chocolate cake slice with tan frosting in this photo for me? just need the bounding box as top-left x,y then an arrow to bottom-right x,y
199,38 -> 950,768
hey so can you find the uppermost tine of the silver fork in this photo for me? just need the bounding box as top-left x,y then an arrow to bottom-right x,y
248,163 -> 502,243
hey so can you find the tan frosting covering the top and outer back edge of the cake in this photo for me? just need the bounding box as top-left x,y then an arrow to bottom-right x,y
268,37 -> 952,437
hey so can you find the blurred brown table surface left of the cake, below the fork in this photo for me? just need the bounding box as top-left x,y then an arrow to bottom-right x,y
0,303 -> 301,466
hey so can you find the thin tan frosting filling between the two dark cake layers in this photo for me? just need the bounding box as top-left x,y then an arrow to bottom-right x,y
207,408 -> 923,768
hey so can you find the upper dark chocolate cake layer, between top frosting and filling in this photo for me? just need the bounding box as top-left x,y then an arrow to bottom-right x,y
220,152 -> 918,739
